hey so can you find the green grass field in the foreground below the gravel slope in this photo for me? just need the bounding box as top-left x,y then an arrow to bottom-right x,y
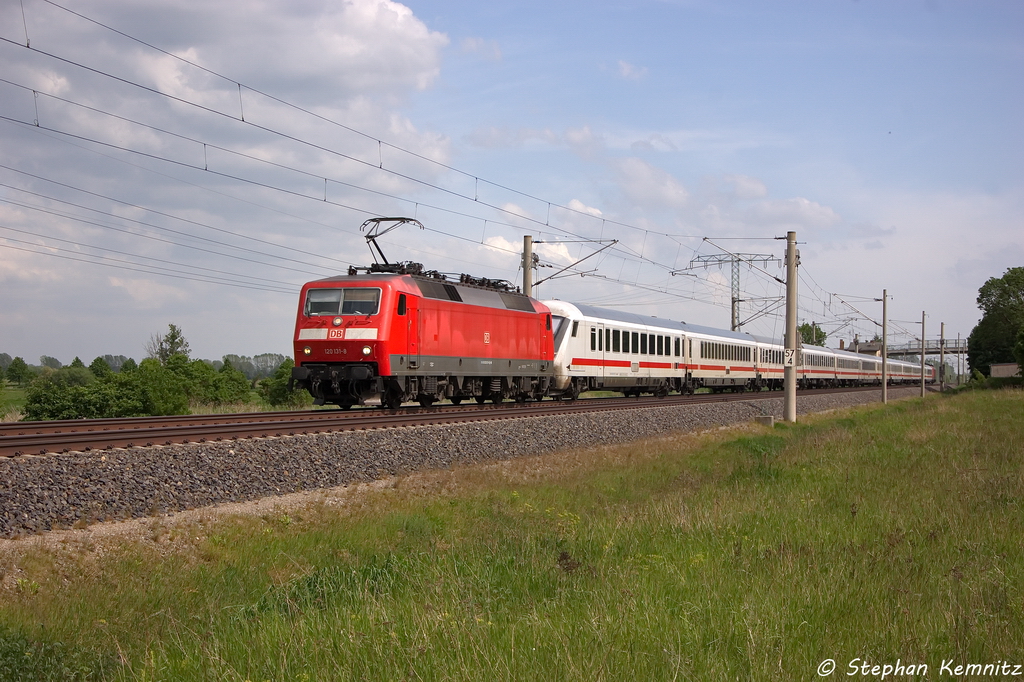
0,390 -> 1024,681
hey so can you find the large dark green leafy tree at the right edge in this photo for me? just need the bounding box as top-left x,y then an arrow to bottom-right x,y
967,267 -> 1024,376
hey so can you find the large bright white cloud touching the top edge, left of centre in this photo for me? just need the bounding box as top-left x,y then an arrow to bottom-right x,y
99,0 -> 450,107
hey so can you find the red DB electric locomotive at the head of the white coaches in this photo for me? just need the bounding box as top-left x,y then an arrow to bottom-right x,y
292,219 -> 554,409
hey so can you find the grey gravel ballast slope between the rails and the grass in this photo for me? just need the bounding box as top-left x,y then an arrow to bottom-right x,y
0,388 -> 920,538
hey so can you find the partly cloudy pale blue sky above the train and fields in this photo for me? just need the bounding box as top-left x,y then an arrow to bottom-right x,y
0,0 -> 1024,364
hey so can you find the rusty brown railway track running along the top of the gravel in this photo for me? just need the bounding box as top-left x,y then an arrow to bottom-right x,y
0,386 -> 880,457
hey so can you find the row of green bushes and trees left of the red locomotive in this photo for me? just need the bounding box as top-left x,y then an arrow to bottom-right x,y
0,325 -> 311,421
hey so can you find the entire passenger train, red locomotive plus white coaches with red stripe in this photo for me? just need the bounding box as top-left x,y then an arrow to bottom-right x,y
292,263 -> 934,409
